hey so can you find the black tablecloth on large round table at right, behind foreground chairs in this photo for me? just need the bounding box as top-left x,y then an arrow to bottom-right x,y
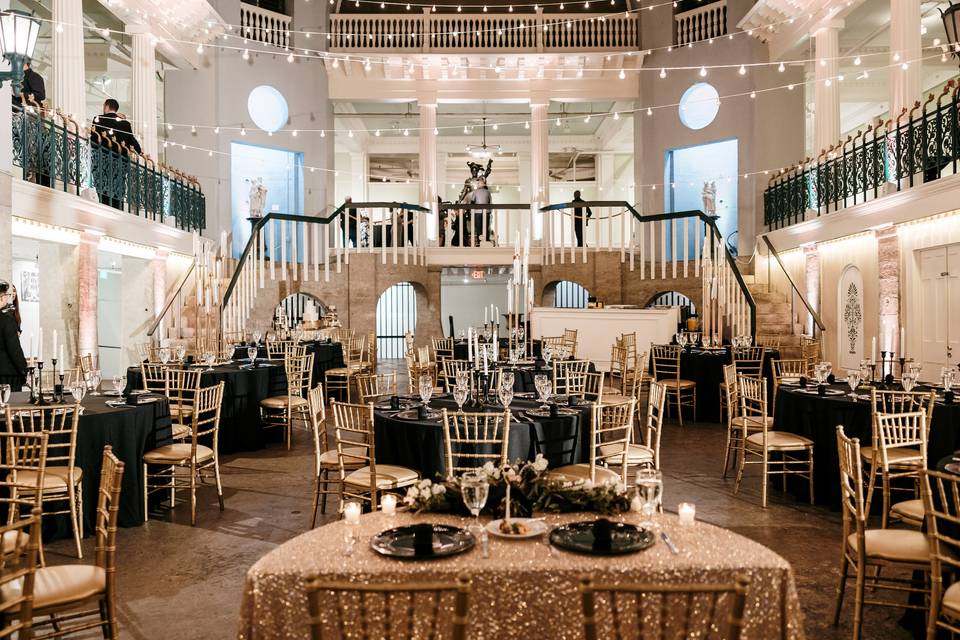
774,384 -> 960,509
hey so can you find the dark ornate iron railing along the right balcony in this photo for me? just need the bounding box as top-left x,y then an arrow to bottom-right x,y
763,81 -> 960,229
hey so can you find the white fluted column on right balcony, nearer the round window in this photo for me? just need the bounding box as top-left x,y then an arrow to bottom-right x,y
813,20 -> 843,155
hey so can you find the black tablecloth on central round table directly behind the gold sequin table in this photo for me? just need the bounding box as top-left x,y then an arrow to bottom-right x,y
374,397 -> 590,478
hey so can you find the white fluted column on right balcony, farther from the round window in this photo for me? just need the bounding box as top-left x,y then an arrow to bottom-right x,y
888,0 -> 923,121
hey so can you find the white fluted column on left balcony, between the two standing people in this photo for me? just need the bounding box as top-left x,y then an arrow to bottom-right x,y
50,0 -> 87,123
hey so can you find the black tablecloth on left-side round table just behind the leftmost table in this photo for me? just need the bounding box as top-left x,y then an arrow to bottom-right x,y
127,362 -> 287,453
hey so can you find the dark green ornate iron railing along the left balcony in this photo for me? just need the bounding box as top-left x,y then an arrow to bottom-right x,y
13,108 -> 206,231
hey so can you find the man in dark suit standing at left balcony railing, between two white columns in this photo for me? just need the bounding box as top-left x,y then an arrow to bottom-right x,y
92,98 -> 141,210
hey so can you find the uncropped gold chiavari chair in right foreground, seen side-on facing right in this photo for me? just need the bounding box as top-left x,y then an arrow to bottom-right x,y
833,425 -> 930,640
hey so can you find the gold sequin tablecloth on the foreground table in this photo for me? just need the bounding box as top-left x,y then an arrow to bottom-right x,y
238,513 -> 804,640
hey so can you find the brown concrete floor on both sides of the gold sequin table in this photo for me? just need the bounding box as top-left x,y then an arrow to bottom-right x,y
47,408 -> 911,640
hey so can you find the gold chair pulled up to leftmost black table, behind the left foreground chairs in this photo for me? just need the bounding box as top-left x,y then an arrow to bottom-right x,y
7,403 -> 83,558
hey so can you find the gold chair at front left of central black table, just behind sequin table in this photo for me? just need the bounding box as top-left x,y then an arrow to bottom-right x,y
330,400 -> 420,511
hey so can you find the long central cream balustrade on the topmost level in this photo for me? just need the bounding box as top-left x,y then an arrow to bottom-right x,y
330,9 -> 640,52
